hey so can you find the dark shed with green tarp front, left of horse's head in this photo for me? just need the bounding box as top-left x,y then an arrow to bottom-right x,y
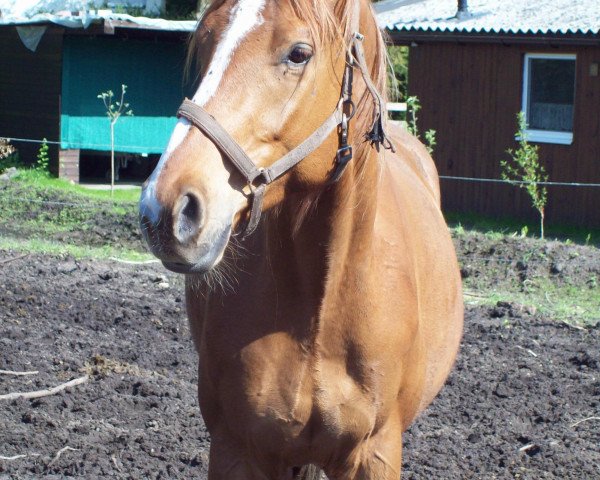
0,11 -> 196,181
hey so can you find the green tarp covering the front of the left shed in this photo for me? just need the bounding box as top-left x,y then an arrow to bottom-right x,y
61,36 -> 185,153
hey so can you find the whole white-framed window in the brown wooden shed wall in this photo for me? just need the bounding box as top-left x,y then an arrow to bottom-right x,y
523,53 -> 576,145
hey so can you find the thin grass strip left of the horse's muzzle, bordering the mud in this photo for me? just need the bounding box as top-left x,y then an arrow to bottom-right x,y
0,236 -> 155,262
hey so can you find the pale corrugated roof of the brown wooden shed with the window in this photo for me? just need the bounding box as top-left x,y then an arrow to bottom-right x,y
374,0 -> 600,35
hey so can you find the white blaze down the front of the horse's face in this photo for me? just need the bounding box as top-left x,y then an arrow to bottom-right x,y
141,0 -> 266,221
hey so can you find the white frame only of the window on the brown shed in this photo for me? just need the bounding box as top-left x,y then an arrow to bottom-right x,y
521,53 -> 577,145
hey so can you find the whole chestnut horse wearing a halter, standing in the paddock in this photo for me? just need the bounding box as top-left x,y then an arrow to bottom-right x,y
139,0 -> 463,480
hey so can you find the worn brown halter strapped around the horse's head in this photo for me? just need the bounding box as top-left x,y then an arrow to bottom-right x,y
177,2 -> 395,238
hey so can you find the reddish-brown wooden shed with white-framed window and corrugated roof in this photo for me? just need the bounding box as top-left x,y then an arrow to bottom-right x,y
375,0 -> 600,227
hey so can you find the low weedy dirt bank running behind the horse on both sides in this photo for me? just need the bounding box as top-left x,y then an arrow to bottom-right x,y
0,179 -> 600,302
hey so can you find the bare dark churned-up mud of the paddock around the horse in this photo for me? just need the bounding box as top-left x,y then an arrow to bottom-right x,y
0,251 -> 600,479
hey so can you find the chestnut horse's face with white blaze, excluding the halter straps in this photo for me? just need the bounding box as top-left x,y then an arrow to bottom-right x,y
140,0 -> 344,272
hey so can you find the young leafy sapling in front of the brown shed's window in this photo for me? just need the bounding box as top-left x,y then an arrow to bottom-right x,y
500,112 -> 548,238
